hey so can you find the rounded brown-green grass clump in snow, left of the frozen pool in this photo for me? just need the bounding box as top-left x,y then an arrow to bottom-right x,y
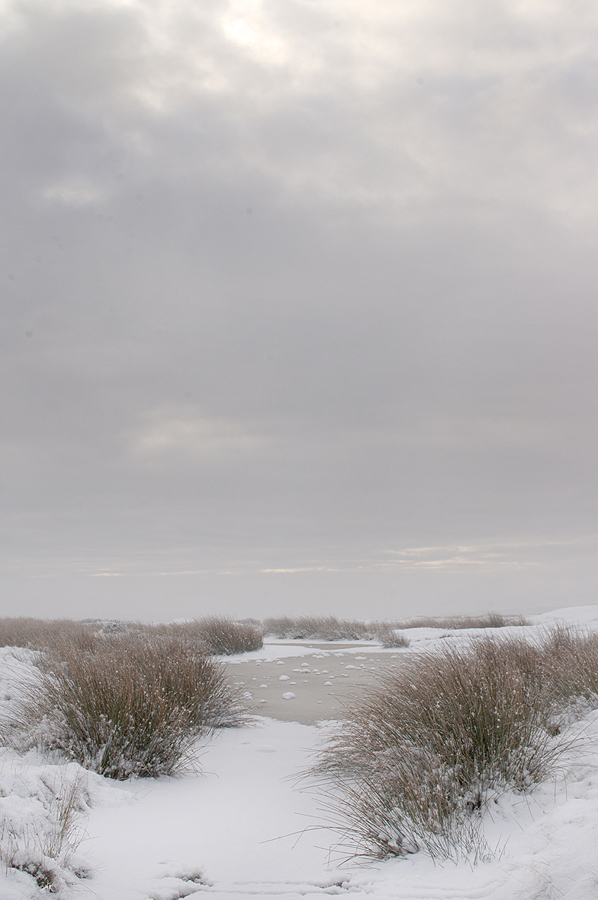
10,635 -> 245,780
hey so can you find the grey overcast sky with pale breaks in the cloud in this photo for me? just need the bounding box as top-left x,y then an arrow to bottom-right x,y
0,0 -> 598,619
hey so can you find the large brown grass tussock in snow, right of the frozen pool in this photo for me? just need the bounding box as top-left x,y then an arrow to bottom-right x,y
308,630 -> 598,858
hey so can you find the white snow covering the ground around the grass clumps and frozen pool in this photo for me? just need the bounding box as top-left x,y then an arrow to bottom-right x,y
0,606 -> 598,900
